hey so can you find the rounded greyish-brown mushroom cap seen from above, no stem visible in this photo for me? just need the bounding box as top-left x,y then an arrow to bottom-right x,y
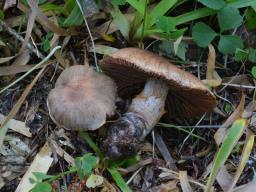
47,65 -> 116,130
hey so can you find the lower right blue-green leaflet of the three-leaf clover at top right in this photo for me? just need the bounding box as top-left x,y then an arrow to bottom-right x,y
218,35 -> 244,55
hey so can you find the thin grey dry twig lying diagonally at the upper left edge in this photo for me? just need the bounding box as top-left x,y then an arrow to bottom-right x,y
0,20 -> 45,59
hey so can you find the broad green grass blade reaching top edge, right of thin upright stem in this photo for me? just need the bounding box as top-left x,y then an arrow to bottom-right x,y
149,0 -> 177,26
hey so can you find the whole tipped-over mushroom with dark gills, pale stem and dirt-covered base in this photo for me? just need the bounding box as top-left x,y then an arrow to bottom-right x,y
100,48 -> 216,159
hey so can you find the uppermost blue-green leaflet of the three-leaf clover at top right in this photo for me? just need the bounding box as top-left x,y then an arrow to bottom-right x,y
218,6 -> 243,32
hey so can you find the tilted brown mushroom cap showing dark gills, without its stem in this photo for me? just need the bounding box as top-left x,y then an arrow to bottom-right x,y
100,48 -> 216,117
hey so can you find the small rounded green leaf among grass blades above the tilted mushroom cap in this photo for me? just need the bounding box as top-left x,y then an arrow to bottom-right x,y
156,16 -> 176,33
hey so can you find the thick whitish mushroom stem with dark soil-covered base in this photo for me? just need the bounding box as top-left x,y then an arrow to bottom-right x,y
103,79 -> 168,159
